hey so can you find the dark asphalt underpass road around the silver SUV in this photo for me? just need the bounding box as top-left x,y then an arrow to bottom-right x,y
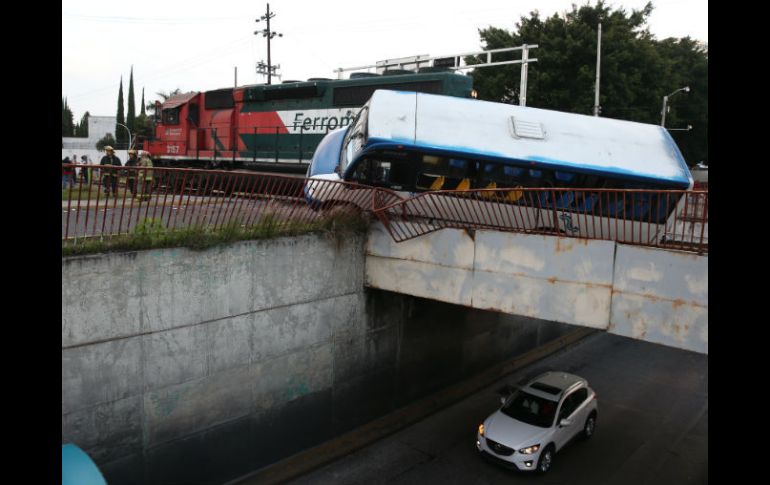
290,332 -> 708,485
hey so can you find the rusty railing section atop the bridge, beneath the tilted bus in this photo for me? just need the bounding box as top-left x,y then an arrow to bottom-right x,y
374,188 -> 708,253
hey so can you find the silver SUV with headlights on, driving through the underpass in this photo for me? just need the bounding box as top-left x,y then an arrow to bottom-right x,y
476,372 -> 598,473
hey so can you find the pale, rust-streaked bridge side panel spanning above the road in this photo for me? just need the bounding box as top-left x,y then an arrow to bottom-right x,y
365,224 -> 708,354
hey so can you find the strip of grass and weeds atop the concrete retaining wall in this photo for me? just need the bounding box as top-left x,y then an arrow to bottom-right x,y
62,205 -> 371,256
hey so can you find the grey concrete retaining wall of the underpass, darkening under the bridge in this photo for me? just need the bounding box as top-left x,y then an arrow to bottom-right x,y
62,236 -> 570,485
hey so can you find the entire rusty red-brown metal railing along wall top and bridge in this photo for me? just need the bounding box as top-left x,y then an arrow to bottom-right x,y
62,165 -> 708,253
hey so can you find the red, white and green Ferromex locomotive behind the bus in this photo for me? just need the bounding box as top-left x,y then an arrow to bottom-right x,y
143,70 -> 473,173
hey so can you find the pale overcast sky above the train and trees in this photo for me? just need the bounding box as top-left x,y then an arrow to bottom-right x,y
62,0 -> 708,122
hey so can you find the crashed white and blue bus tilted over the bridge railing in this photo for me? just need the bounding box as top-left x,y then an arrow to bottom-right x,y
306,90 -> 693,242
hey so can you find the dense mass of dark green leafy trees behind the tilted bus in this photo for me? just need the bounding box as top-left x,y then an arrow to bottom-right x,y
466,0 -> 708,164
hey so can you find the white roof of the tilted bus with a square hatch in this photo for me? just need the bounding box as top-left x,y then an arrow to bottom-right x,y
368,90 -> 692,188
